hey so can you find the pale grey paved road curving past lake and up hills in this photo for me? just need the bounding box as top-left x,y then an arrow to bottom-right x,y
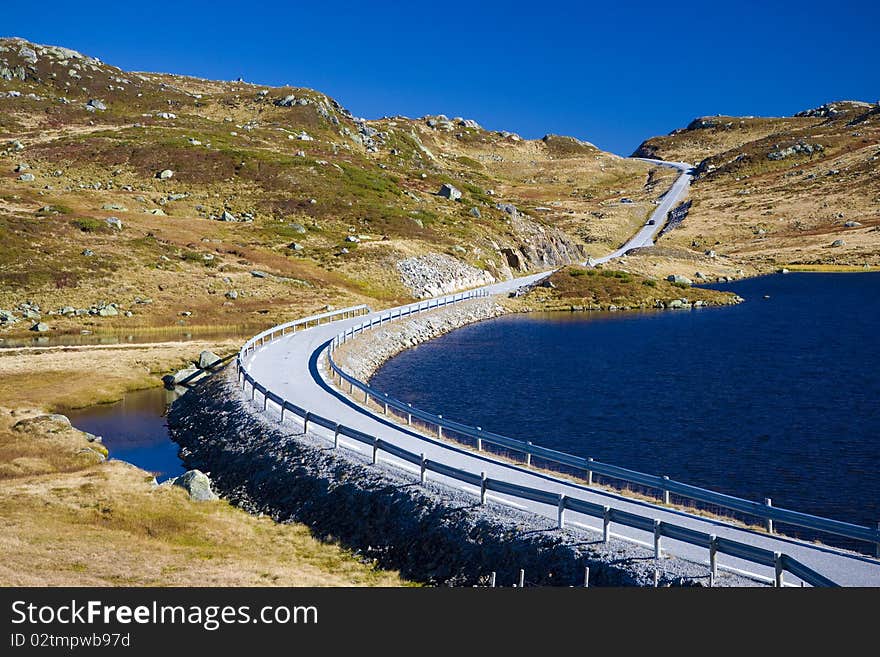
244,158 -> 880,586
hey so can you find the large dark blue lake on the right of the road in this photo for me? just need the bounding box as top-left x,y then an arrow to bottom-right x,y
372,273 -> 880,536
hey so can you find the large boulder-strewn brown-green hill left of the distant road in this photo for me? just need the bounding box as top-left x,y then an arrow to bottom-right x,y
0,39 -> 673,333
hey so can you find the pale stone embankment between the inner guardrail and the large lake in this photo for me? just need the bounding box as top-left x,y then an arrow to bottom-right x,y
333,297 -> 509,381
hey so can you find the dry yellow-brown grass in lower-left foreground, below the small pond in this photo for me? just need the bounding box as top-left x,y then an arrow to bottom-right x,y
0,409 -> 403,586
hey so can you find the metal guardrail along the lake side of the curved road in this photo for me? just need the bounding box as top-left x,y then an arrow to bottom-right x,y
327,306 -> 880,556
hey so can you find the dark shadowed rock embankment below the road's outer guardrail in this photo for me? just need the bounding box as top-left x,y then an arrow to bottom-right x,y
168,369 -> 750,586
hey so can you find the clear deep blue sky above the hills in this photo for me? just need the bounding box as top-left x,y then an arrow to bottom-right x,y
0,0 -> 880,155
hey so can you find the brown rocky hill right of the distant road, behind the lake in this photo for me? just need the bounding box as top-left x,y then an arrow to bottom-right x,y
636,101 -> 880,269
